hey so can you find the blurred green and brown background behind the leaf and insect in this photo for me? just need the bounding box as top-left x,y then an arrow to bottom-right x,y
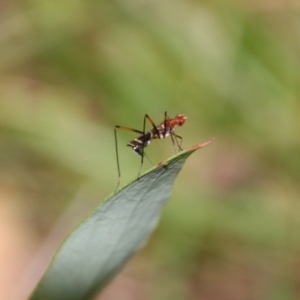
0,0 -> 300,300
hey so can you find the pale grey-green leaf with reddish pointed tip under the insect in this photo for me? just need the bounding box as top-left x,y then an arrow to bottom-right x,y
30,140 -> 213,300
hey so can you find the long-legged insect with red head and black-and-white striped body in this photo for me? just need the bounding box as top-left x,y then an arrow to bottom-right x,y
114,112 -> 187,190
